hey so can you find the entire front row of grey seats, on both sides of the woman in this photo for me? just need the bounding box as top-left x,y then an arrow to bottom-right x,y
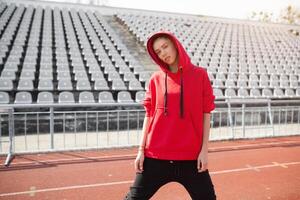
0,88 -> 300,104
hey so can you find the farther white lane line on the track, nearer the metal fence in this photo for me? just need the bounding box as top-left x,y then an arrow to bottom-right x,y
5,141 -> 300,166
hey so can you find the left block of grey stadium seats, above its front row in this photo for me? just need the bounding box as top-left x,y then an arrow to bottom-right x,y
0,3 -> 151,103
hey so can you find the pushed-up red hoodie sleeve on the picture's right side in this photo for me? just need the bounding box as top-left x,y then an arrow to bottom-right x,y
203,71 -> 215,113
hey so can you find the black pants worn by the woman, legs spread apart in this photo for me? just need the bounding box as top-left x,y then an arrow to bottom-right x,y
124,158 -> 216,200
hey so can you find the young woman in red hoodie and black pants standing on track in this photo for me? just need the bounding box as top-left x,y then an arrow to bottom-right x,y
125,32 -> 216,200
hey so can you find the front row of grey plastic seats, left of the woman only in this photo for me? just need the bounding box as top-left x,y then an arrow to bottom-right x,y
0,91 -> 145,104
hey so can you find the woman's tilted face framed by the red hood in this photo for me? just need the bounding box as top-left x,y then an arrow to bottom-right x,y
153,37 -> 178,66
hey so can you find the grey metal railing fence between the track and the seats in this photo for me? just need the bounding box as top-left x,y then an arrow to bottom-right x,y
0,100 -> 300,165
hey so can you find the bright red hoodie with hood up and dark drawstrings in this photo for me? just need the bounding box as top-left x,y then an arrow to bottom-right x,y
144,32 -> 215,160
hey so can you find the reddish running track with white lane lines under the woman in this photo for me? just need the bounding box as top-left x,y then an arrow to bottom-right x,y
0,137 -> 300,200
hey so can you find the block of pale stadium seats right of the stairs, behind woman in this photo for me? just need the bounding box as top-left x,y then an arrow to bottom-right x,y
116,13 -> 300,99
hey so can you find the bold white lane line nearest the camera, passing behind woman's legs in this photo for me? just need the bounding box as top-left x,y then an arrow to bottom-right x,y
0,161 -> 300,197
